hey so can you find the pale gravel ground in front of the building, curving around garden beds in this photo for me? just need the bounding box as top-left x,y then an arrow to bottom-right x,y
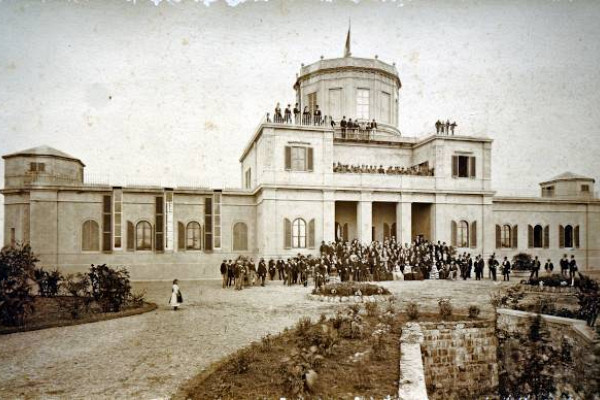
0,280 -> 513,399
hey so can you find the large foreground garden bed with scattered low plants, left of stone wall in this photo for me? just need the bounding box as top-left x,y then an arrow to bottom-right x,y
173,303 -> 474,400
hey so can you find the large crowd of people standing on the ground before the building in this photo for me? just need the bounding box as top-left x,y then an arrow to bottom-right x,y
220,237 -> 577,290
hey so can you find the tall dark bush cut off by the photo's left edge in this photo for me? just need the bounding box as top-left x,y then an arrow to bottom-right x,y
0,245 -> 39,326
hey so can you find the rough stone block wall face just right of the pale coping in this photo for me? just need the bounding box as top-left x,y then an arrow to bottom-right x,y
421,321 -> 498,400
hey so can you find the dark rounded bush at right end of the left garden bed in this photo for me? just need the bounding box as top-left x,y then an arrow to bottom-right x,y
88,264 -> 131,312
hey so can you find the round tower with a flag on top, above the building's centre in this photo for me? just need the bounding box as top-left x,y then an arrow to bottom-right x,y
294,31 -> 402,135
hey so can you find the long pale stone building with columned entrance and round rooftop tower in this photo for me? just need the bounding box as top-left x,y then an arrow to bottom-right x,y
2,57 -> 600,279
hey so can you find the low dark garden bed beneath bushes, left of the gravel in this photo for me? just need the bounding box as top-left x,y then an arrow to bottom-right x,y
0,296 -> 157,334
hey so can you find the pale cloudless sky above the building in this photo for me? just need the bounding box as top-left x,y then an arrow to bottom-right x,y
0,0 -> 600,242
